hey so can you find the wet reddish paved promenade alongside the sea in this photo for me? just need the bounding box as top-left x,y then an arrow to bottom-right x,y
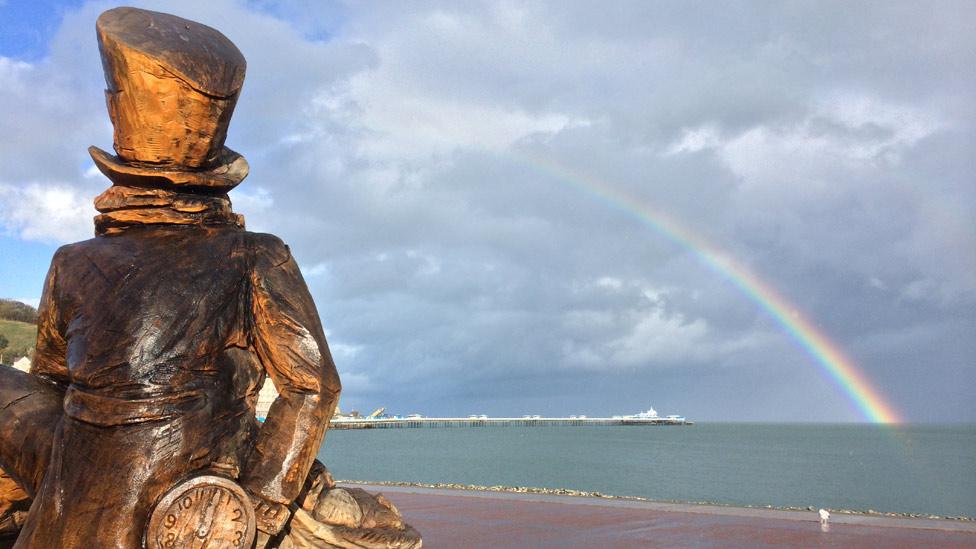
354,485 -> 976,549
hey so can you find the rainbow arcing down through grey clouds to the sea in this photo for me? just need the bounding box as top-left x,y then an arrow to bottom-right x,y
519,154 -> 902,423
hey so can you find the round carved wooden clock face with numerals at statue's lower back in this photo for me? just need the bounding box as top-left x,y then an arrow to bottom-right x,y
146,475 -> 255,549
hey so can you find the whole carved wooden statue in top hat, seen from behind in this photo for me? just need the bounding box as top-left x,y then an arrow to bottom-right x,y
0,8 -> 420,549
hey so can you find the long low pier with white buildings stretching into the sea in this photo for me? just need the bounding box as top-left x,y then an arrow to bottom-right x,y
329,416 -> 694,429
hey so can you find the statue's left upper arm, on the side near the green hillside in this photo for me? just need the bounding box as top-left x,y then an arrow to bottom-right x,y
30,248 -> 69,390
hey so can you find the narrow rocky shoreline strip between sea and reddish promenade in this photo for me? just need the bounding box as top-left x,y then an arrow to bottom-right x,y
336,480 -> 976,522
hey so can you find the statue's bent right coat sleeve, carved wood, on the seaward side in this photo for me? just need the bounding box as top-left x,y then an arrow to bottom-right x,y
241,236 -> 340,504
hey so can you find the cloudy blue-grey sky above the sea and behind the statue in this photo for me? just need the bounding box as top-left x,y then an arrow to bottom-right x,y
0,0 -> 976,422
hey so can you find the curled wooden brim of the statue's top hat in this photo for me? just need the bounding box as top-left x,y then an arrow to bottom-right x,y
88,146 -> 250,193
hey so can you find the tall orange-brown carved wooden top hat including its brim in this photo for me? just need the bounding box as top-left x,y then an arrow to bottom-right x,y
90,8 -> 248,191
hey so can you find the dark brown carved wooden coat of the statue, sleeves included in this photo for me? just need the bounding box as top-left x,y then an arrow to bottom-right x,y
0,223 -> 339,549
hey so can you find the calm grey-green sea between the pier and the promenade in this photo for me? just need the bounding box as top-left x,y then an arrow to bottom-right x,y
319,423 -> 976,517
